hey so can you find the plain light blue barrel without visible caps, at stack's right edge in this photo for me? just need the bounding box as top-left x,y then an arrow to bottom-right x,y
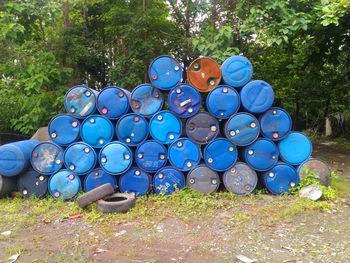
278,132 -> 312,165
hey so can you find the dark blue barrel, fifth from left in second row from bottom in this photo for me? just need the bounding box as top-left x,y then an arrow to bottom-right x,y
135,141 -> 168,173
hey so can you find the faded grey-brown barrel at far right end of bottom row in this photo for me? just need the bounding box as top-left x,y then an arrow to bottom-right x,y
297,158 -> 331,186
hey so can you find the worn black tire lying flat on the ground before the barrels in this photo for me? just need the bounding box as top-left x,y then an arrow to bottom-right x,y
97,193 -> 136,213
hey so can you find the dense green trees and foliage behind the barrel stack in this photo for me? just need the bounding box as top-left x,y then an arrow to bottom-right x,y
0,0 -> 350,134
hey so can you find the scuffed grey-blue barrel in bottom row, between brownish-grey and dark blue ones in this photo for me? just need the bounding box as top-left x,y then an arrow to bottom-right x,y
222,162 -> 258,195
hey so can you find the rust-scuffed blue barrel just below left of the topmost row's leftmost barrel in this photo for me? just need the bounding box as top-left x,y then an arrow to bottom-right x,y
130,84 -> 164,117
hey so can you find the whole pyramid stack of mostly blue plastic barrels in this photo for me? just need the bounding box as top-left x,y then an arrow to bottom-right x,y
0,55 -> 330,200
